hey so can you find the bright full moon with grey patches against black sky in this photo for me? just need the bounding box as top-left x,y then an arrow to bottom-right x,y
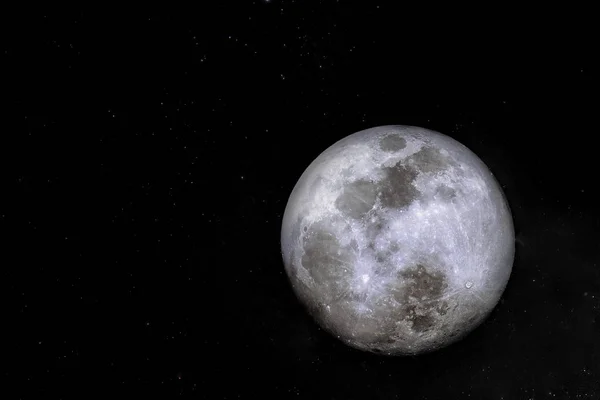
281,125 -> 515,355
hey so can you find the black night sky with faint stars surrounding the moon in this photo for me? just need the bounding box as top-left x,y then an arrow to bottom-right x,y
5,0 -> 600,399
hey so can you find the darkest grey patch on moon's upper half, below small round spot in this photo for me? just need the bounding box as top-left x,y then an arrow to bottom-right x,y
380,163 -> 421,208
